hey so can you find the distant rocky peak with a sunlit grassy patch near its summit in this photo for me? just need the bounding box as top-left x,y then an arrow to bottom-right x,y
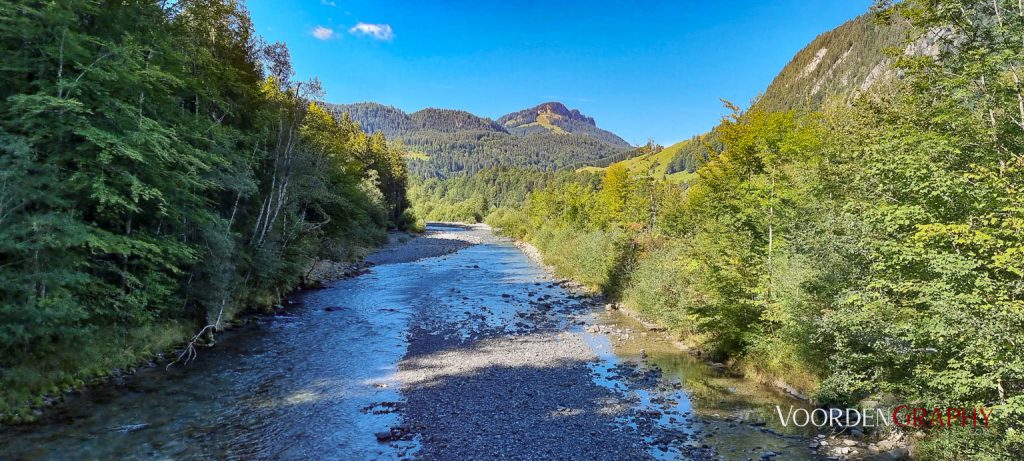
498,102 -> 630,148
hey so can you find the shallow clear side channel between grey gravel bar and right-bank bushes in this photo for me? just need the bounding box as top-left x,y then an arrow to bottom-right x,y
584,311 -> 815,460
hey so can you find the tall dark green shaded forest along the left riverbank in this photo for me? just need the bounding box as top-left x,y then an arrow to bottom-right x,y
0,0 -> 409,421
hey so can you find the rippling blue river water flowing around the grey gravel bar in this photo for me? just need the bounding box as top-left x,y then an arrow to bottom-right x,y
0,225 -> 814,460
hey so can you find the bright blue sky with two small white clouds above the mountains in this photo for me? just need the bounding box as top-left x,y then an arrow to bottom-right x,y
247,0 -> 872,145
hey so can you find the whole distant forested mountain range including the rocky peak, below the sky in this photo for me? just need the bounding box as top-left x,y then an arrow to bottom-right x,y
325,102 -> 632,177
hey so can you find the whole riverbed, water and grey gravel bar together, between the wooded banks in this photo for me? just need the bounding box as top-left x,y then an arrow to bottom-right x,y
0,224 -> 814,460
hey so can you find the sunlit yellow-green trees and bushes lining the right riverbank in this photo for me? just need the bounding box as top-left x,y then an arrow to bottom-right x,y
413,0 -> 1024,460
